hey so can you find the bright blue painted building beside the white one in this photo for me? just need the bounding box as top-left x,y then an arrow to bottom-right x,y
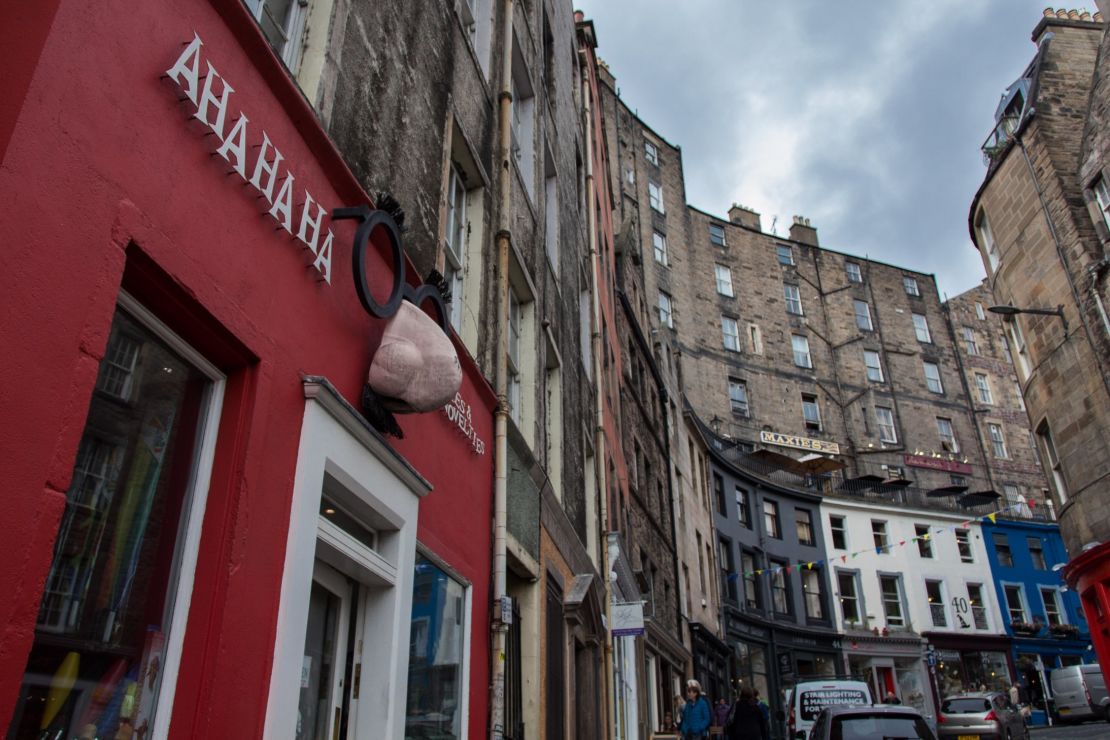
982,516 -> 1096,722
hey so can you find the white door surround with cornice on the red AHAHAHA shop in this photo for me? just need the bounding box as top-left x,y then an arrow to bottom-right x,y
263,382 -> 428,738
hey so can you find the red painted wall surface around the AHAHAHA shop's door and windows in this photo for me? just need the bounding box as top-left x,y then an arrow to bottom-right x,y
0,0 -> 494,738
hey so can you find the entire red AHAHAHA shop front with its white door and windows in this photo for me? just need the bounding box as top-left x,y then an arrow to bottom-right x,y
0,0 -> 495,739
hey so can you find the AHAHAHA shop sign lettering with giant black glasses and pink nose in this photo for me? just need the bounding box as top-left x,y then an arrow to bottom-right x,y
165,33 -> 462,428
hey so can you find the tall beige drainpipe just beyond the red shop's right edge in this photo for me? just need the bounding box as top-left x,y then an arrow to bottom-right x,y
490,0 -> 513,740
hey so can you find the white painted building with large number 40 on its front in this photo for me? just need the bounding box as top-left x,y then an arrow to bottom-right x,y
821,496 -> 1010,718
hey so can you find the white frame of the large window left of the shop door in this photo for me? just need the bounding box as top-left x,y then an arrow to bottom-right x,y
110,291 -> 227,738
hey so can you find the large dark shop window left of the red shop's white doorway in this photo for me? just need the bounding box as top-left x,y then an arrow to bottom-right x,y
8,295 -> 223,738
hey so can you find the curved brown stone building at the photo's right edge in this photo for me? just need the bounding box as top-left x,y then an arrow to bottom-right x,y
968,9 -> 1110,678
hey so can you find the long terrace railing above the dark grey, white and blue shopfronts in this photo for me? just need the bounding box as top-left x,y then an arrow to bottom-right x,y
718,447 -> 1056,521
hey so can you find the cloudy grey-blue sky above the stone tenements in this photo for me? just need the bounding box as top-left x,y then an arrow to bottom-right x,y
576,0 -> 1070,296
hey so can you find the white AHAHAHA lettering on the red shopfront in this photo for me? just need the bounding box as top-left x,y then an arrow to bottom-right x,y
165,33 -> 334,283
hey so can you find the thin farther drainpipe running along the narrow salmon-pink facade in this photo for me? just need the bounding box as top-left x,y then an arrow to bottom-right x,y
582,53 -> 618,738
